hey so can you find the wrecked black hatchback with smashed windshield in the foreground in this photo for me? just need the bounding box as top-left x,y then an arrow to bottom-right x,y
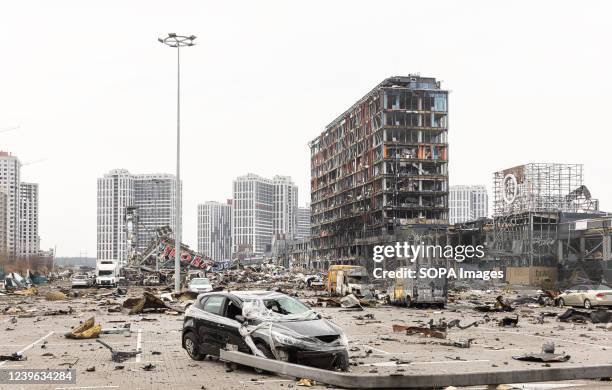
182,291 -> 348,371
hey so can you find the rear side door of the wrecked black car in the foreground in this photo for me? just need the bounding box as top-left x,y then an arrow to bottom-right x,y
198,295 -> 226,356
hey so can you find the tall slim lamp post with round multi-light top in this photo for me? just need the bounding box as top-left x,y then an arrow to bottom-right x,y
157,33 -> 196,292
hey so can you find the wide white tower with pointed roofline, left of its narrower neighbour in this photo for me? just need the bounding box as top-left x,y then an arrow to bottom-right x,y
232,173 -> 274,255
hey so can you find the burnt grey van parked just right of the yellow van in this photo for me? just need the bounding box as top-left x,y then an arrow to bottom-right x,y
387,265 -> 448,307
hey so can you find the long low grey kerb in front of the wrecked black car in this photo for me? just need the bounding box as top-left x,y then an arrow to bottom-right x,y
221,350 -> 612,389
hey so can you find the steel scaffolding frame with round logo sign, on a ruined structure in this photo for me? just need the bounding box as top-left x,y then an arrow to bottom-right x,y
492,163 -> 598,266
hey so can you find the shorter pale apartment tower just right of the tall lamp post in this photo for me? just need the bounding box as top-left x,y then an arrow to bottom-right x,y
198,202 -> 232,261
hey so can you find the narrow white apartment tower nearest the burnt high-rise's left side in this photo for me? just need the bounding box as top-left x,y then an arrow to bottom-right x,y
272,175 -> 298,239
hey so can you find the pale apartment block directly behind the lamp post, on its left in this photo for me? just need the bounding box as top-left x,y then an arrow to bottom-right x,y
133,174 -> 176,252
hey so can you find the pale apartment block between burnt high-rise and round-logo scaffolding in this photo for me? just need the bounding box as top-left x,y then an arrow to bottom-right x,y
448,185 -> 489,224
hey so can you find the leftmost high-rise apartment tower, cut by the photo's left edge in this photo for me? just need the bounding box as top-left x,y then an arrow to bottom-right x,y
0,151 -> 21,257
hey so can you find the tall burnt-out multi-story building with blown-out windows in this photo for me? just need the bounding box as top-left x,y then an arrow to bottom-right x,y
310,75 -> 448,267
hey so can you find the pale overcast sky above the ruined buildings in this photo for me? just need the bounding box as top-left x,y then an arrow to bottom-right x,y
0,0 -> 612,256
